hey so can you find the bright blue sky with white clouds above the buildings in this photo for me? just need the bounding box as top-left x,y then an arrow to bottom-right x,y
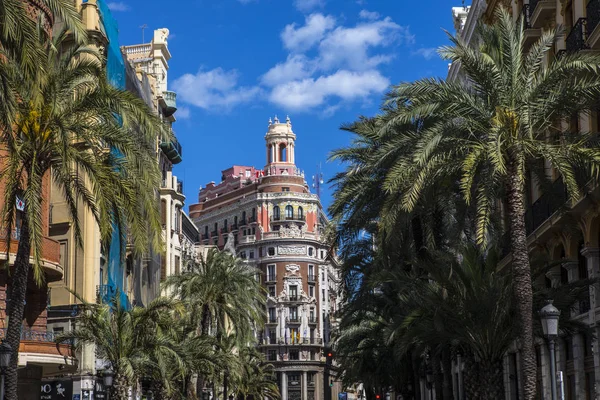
109,0 -> 460,214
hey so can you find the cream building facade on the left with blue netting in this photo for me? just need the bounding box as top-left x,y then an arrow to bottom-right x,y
46,0 -> 185,399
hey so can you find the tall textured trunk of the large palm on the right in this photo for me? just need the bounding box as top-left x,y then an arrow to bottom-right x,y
508,157 -> 537,400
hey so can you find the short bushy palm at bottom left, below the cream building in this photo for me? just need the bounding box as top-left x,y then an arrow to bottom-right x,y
56,295 -> 184,400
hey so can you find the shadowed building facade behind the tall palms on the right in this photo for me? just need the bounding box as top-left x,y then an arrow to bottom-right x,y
448,0 -> 600,400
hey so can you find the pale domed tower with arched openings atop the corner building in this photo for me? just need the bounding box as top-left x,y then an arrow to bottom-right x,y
265,116 -> 296,175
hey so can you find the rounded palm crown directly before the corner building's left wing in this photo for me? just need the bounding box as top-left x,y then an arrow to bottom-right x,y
164,249 -> 265,393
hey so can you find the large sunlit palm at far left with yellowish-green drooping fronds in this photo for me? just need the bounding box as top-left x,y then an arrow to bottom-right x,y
0,32 -> 163,399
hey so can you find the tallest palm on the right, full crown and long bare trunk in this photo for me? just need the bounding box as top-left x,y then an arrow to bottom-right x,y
338,9 -> 600,399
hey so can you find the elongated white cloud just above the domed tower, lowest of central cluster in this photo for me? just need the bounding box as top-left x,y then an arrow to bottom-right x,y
269,70 -> 390,112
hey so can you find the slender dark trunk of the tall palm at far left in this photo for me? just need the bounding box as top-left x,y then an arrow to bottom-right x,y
5,211 -> 31,400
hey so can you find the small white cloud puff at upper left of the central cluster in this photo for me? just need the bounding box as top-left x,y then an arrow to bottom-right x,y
281,13 -> 335,52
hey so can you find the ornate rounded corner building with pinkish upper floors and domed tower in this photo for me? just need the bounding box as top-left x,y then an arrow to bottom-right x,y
190,117 -> 339,400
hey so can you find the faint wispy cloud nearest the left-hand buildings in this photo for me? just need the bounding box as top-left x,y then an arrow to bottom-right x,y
173,68 -> 260,111
